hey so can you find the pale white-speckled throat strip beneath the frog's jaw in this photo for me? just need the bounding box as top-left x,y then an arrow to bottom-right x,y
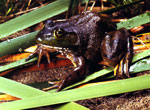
39,44 -> 77,67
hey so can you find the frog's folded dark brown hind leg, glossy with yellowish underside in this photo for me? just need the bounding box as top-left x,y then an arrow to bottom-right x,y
101,28 -> 133,78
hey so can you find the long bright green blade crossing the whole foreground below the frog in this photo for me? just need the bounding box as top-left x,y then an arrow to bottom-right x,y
0,75 -> 150,110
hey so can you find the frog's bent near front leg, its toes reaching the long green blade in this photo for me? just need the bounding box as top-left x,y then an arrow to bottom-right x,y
43,51 -> 86,92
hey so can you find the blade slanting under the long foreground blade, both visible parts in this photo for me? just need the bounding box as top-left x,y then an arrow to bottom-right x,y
0,77 -> 88,110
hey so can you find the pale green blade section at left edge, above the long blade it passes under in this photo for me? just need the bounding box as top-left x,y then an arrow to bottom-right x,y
0,77 -> 48,98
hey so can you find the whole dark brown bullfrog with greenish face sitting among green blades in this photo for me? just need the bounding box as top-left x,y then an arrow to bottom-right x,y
27,12 -> 133,91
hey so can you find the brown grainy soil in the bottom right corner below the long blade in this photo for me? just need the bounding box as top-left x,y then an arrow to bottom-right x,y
78,90 -> 150,110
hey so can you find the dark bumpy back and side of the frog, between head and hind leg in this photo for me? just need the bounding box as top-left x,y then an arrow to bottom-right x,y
70,12 -> 116,62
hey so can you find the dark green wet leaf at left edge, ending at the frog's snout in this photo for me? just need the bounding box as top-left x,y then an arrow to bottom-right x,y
0,31 -> 39,57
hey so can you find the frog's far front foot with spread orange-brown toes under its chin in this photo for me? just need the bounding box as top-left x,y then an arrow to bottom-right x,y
26,44 -> 55,67
